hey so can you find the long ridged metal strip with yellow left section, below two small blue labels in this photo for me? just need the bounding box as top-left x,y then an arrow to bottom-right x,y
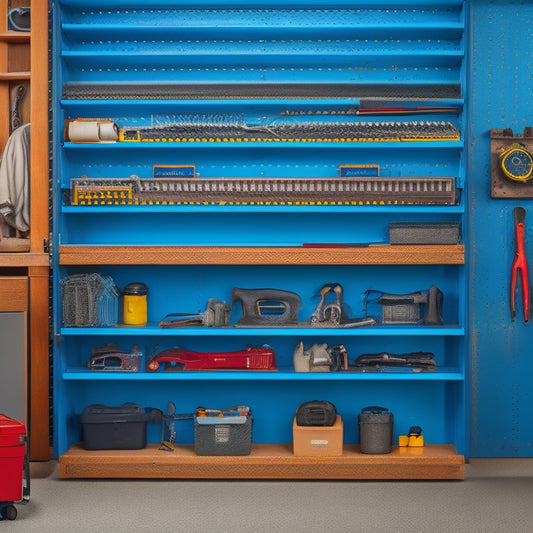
71,177 -> 456,206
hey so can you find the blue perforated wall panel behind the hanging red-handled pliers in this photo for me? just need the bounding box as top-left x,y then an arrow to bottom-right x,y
469,0 -> 533,457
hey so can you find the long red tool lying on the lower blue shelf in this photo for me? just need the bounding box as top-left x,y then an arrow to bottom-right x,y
147,347 -> 276,372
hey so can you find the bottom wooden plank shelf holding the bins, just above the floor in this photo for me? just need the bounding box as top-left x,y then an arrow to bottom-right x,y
59,444 -> 465,480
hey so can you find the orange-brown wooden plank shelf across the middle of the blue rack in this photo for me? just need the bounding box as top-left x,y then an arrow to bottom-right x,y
59,244 -> 464,265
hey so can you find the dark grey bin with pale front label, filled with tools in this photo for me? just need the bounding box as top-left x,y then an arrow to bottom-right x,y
194,413 -> 254,455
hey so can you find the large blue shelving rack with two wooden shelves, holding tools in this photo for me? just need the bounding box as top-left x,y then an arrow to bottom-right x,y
52,0 -> 469,479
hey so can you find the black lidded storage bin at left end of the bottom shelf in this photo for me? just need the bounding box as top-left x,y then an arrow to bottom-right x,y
80,403 -> 149,450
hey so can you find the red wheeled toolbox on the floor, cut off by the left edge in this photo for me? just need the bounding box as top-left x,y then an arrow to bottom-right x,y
0,414 -> 27,520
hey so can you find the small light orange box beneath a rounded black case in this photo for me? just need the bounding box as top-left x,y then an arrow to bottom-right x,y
292,415 -> 344,457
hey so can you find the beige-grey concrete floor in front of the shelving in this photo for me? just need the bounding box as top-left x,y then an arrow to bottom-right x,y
0,459 -> 533,533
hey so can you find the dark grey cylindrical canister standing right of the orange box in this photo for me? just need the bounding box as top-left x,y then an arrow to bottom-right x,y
359,406 -> 394,454
